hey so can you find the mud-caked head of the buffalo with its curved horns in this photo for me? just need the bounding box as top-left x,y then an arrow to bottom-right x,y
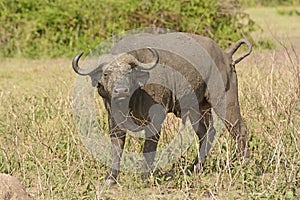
72,48 -> 159,101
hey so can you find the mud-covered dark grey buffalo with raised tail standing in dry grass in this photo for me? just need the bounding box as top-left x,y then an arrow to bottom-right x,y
72,32 -> 252,184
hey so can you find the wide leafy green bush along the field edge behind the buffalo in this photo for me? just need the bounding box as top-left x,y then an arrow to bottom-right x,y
0,0 -> 254,58
